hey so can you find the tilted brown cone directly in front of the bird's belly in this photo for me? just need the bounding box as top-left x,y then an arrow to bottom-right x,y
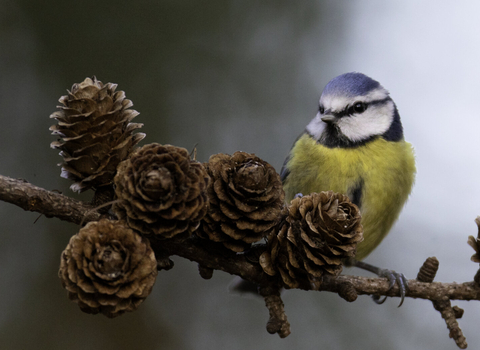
260,191 -> 363,288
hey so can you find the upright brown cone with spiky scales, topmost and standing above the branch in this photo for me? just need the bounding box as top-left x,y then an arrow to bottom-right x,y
50,77 -> 145,192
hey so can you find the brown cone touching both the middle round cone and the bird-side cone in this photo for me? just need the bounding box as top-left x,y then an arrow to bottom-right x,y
197,152 -> 285,252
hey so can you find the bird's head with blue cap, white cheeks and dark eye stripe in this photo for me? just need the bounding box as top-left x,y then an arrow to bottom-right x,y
306,73 -> 403,147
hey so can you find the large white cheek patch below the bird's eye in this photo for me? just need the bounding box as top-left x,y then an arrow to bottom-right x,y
337,101 -> 394,141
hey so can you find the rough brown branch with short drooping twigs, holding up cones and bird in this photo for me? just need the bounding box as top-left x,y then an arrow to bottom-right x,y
0,175 -> 480,348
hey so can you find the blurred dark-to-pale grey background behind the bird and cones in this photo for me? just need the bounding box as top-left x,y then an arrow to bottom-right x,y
0,0 -> 480,350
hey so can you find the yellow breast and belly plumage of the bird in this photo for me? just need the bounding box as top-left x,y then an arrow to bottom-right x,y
284,134 -> 415,260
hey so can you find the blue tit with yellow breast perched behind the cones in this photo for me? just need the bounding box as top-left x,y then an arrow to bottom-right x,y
280,72 -> 416,306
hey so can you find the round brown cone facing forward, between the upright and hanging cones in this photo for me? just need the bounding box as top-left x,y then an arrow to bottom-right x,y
113,143 -> 209,238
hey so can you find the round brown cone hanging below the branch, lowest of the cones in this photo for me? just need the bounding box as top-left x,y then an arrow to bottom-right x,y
58,219 -> 157,317
